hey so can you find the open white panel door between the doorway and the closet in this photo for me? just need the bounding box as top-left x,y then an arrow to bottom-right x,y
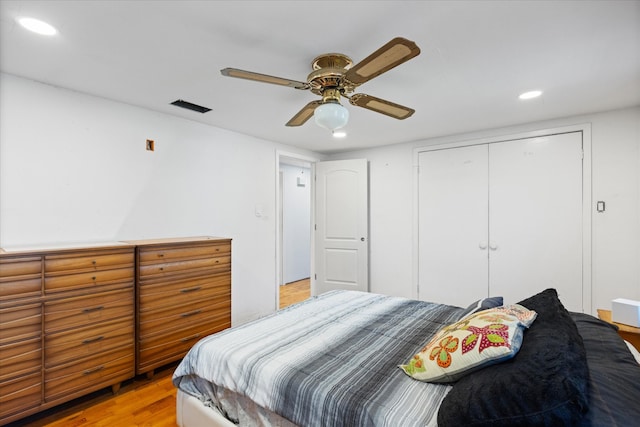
315,159 -> 369,295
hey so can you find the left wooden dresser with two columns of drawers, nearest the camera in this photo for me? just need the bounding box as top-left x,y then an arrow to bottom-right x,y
0,243 -> 135,424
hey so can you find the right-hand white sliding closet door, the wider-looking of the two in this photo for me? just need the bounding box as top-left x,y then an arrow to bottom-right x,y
489,132 -> 583,311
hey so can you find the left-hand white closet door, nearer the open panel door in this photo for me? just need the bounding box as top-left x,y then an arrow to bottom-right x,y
418,145 -> 488,307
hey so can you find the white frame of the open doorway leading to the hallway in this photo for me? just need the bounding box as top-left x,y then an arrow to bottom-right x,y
274,150 -> 322,311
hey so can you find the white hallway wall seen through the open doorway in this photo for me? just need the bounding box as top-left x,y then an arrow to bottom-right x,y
280,164 -> 311,284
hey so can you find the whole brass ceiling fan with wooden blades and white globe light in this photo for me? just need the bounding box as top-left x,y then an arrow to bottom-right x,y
220,37 -> 420,131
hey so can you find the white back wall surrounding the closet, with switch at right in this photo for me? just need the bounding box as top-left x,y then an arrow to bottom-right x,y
331,108 -> 640,313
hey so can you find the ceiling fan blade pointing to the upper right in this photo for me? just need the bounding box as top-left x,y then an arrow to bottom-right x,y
345,37 -> 420,86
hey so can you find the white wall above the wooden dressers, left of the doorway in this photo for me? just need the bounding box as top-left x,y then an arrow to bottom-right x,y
0,74 -> 317,324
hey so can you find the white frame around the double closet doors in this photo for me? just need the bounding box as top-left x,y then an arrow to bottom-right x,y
412,123 -> 594,314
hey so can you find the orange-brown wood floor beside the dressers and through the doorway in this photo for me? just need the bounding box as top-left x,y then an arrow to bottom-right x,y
6,279 -> 311,427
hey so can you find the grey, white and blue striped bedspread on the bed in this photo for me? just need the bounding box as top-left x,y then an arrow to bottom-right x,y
173,291 -> 462,427
